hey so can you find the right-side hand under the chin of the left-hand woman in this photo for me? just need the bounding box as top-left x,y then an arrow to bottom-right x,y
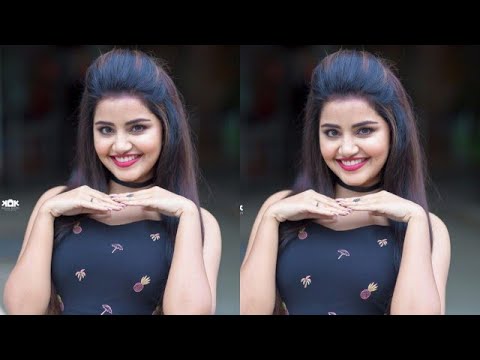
110,186 -> 198,217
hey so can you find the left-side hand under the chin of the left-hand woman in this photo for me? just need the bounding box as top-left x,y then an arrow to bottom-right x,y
42,185 -> 124,217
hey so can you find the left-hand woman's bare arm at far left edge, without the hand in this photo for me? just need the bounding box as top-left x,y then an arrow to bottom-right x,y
3,186 -> 65,314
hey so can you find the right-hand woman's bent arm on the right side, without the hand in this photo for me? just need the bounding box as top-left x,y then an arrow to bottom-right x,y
391,209 -> 450,315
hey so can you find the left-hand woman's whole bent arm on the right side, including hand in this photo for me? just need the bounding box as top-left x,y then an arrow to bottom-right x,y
110,186 -> 221,314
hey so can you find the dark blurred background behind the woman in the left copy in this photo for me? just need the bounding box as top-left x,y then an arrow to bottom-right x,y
0,45 -> 240,314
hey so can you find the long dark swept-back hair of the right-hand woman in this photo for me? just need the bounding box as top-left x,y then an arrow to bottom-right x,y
276,50 -> 432,314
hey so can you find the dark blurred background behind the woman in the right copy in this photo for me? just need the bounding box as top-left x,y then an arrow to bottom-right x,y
240,45 -> 480,314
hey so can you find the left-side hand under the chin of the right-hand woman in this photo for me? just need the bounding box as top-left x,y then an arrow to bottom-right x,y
266,190 -> 350,222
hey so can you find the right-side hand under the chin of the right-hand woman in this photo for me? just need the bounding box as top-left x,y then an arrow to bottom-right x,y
336,190 -> 426,223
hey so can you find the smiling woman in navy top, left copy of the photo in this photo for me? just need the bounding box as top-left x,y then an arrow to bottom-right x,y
4,50 -> 221,315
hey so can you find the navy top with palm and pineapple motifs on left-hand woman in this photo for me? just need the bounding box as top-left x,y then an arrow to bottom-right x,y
52,217 -> 173,315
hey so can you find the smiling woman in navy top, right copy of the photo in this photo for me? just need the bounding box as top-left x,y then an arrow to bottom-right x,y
240,50 -> 450,315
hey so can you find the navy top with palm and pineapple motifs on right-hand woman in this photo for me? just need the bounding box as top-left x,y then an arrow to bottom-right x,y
277,222 -> 397,315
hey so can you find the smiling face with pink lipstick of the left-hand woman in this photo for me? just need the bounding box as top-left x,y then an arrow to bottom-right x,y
93,96 -> 162,182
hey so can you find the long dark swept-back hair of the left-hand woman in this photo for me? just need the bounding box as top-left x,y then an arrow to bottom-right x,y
49,49 -> 204,312
